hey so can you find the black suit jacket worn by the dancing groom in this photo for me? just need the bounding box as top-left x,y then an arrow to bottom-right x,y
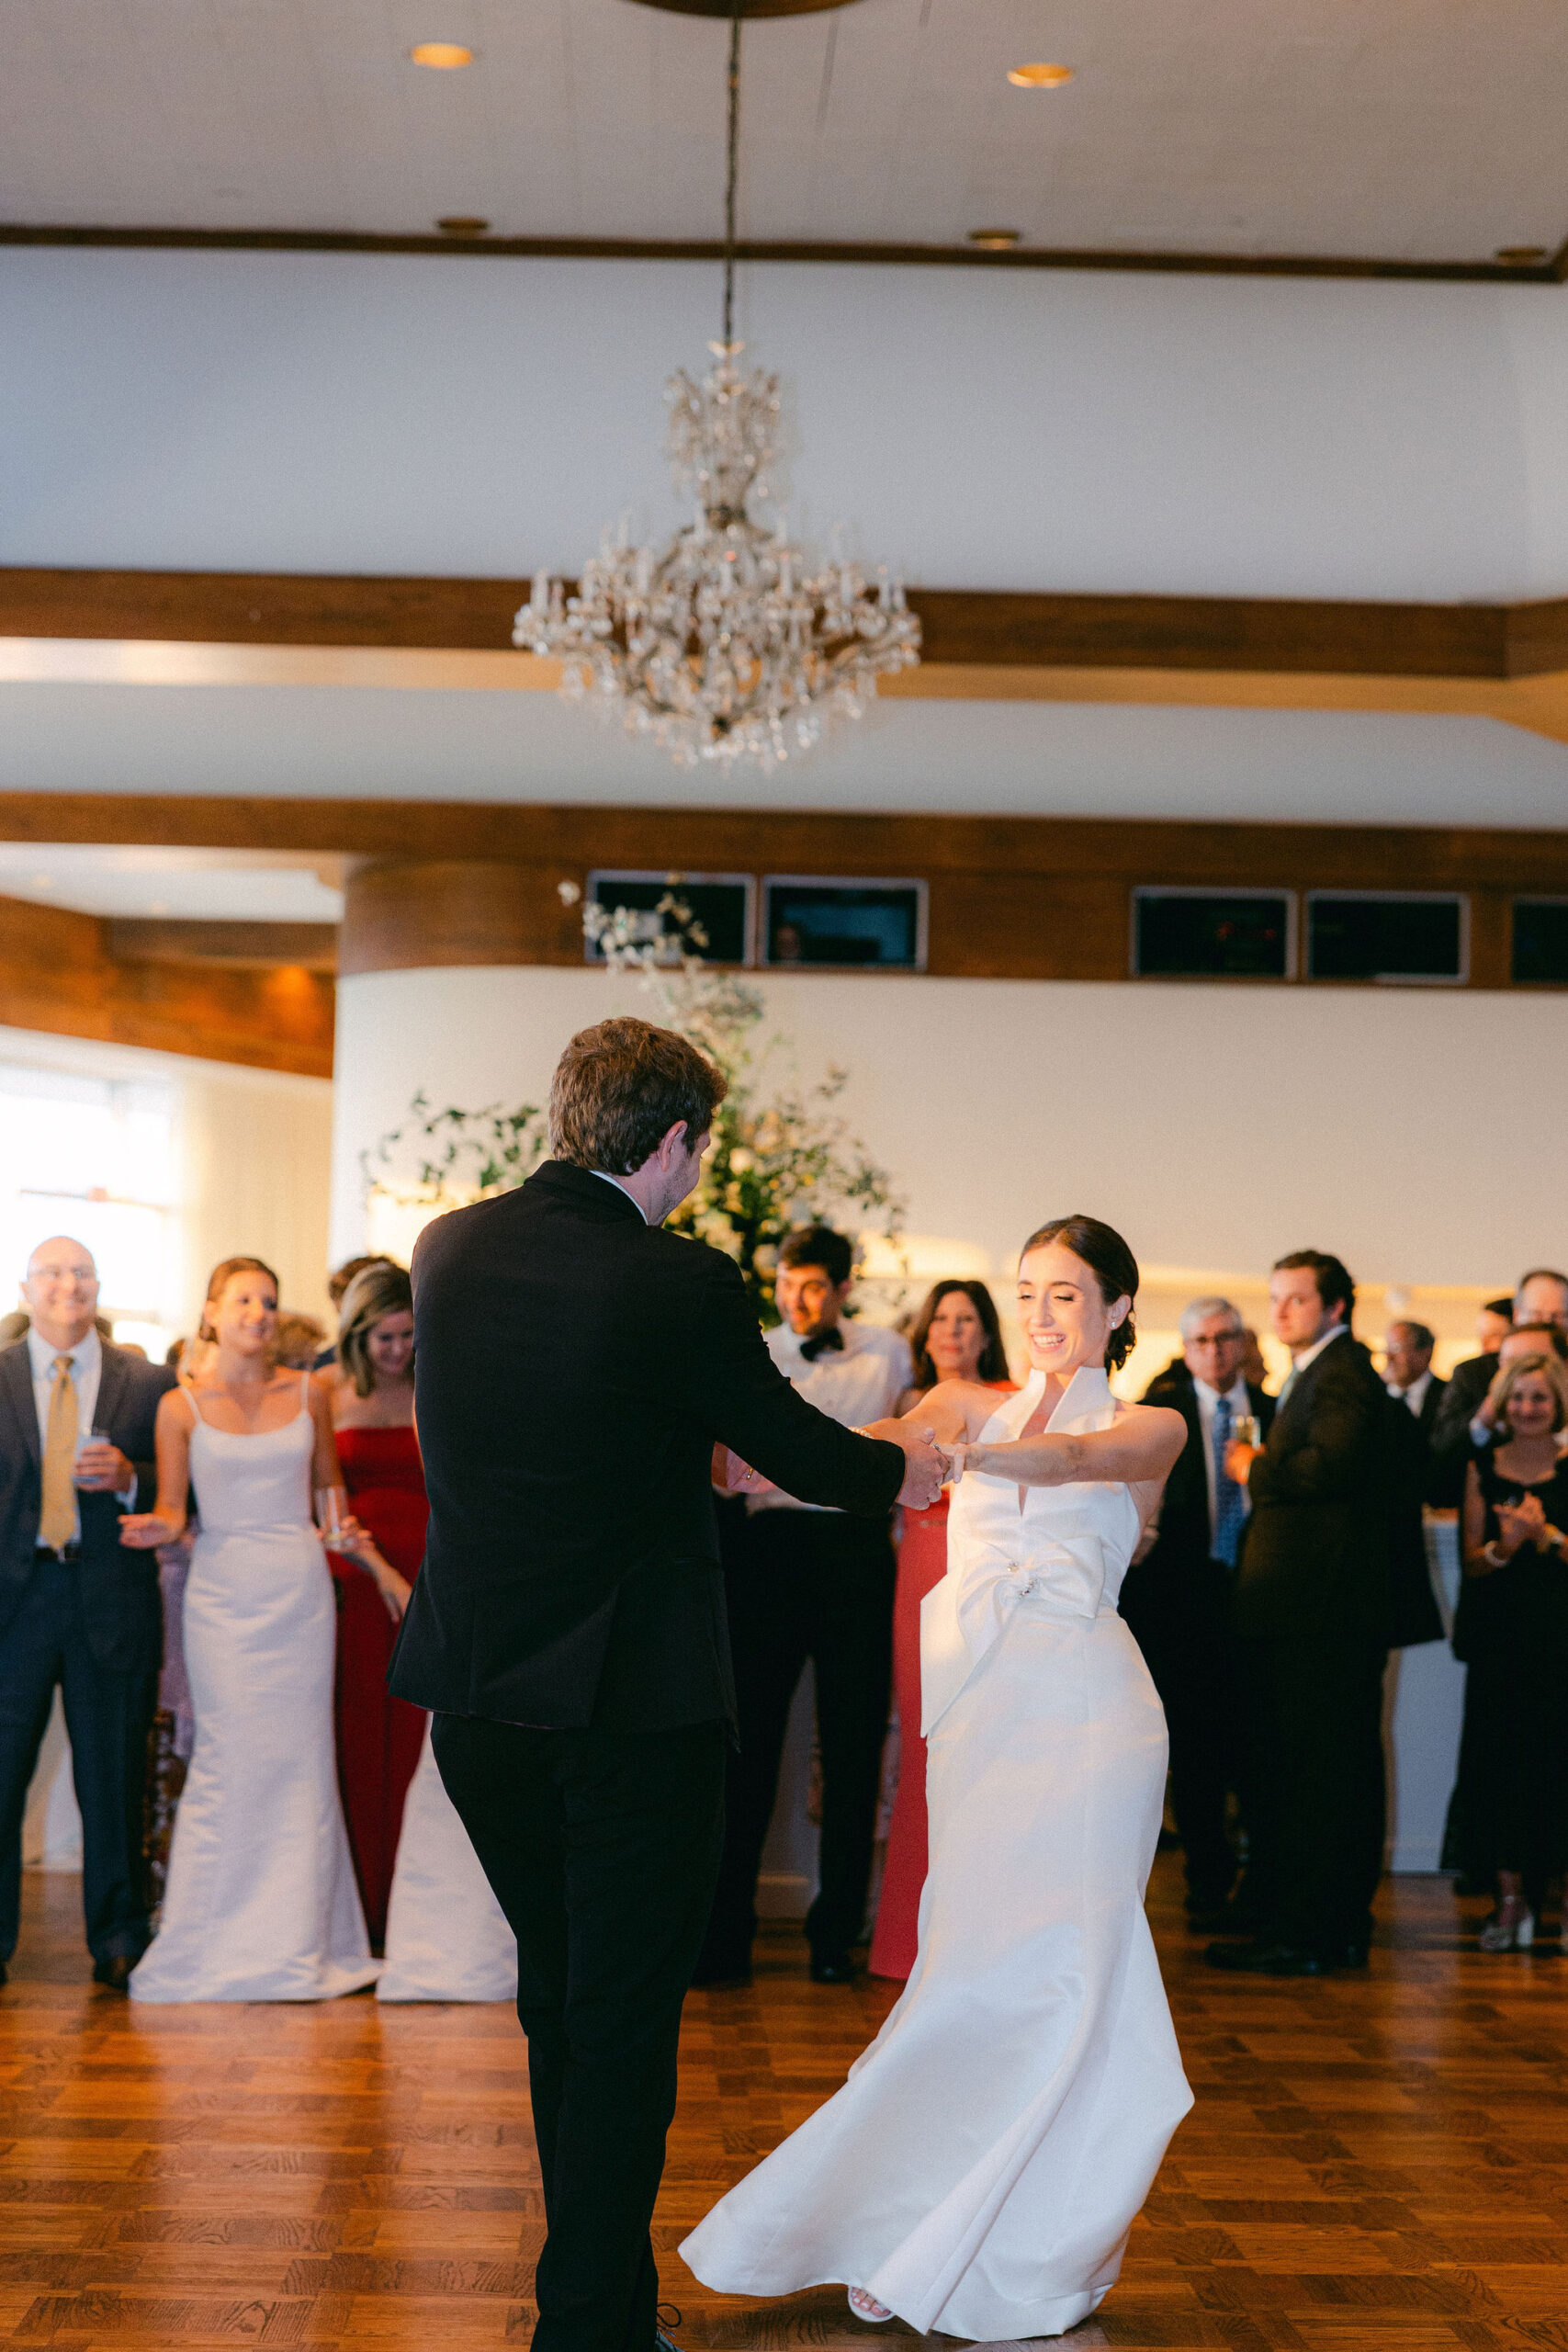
388,1159 -> 903,1731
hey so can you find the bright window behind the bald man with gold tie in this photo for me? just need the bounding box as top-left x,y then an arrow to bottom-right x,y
0,1063 -> 179,1352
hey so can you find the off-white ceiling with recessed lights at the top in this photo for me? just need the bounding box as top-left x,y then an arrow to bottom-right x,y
0,0 -> 1568,259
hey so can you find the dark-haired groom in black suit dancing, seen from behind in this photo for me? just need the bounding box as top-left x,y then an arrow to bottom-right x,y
388,1021 -> 945,2352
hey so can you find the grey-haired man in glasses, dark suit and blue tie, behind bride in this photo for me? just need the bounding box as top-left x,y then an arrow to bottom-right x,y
1119,1298 -> 1274,1924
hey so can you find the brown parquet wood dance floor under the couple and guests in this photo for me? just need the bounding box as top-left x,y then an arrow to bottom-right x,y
0,1858 -> 1568,2352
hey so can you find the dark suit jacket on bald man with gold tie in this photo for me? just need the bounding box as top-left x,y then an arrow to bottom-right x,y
0,1339 -> 174,1675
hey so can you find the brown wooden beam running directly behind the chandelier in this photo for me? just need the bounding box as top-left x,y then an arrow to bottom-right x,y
0,567 -> 1568,680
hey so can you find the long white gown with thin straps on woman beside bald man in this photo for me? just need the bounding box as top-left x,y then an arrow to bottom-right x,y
130,1381 -> 381,2002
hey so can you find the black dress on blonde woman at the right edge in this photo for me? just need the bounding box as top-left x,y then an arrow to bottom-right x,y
1453,1449 -> 1568,1910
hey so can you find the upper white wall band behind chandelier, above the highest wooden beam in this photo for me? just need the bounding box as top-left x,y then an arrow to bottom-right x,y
0,249 -> 1568,600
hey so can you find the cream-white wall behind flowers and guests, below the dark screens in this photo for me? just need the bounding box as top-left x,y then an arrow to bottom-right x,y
332,969 -> 1568,1284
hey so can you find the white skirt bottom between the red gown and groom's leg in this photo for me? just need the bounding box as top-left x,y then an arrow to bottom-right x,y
376,1724 -> 517,2002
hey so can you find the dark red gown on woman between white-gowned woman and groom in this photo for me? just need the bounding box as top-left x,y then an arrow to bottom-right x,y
329,1428 -> 430,1950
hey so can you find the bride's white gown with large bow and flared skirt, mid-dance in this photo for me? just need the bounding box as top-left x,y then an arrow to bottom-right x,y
682,1371 -> 1192,2343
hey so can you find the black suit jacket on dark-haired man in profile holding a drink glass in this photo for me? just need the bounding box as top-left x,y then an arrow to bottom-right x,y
1235,1336 -> 1441,1649
